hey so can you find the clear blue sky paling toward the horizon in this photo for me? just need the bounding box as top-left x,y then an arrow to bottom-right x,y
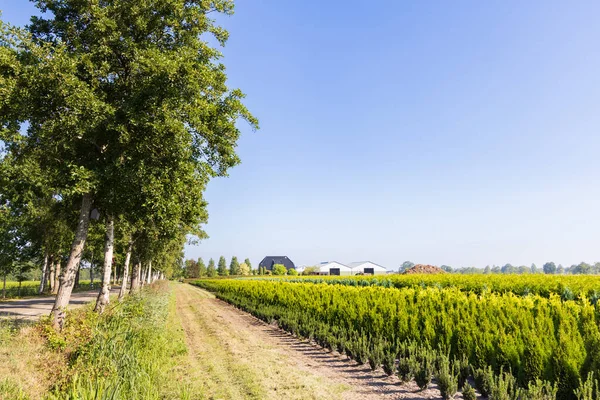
0,0 -> 600,269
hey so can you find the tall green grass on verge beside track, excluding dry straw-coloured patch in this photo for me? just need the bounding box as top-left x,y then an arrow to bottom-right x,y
0,282 -> 189,400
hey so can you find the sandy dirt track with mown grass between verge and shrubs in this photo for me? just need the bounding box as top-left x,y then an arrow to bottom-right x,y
175,284 -> 461,400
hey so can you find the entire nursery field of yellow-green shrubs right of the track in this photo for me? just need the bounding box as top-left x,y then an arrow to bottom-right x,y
194,275 -> 600,399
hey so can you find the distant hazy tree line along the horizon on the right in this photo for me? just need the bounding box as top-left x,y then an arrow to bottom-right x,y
398,261 -> 600,275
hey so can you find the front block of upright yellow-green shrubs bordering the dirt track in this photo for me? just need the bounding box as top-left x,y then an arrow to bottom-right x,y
195,280 -> 600,399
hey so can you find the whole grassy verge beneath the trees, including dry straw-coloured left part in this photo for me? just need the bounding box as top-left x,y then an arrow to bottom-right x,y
0,282 -> 190,400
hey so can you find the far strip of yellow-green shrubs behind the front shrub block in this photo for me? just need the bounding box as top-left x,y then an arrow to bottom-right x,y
258,274 -> 600,304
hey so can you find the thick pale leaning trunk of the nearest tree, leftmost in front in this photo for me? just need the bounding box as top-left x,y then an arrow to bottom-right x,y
51,193 -> 92,330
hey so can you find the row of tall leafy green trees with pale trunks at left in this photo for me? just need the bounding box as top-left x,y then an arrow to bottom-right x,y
0,0 -> 257,329
